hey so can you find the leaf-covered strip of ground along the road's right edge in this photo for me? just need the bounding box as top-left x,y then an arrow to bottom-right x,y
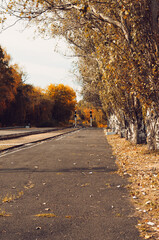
107,135 -> 159,240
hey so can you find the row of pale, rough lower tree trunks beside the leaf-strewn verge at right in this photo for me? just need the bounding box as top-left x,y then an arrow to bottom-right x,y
108,109 -> 159,150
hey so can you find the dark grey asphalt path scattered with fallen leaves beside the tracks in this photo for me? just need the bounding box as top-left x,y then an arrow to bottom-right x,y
0,129 -> 140,240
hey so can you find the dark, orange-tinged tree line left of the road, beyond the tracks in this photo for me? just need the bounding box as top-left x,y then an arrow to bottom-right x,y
0,47 -> 76,127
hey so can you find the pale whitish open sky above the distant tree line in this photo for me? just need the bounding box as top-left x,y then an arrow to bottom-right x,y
0,19 -> 80,100
